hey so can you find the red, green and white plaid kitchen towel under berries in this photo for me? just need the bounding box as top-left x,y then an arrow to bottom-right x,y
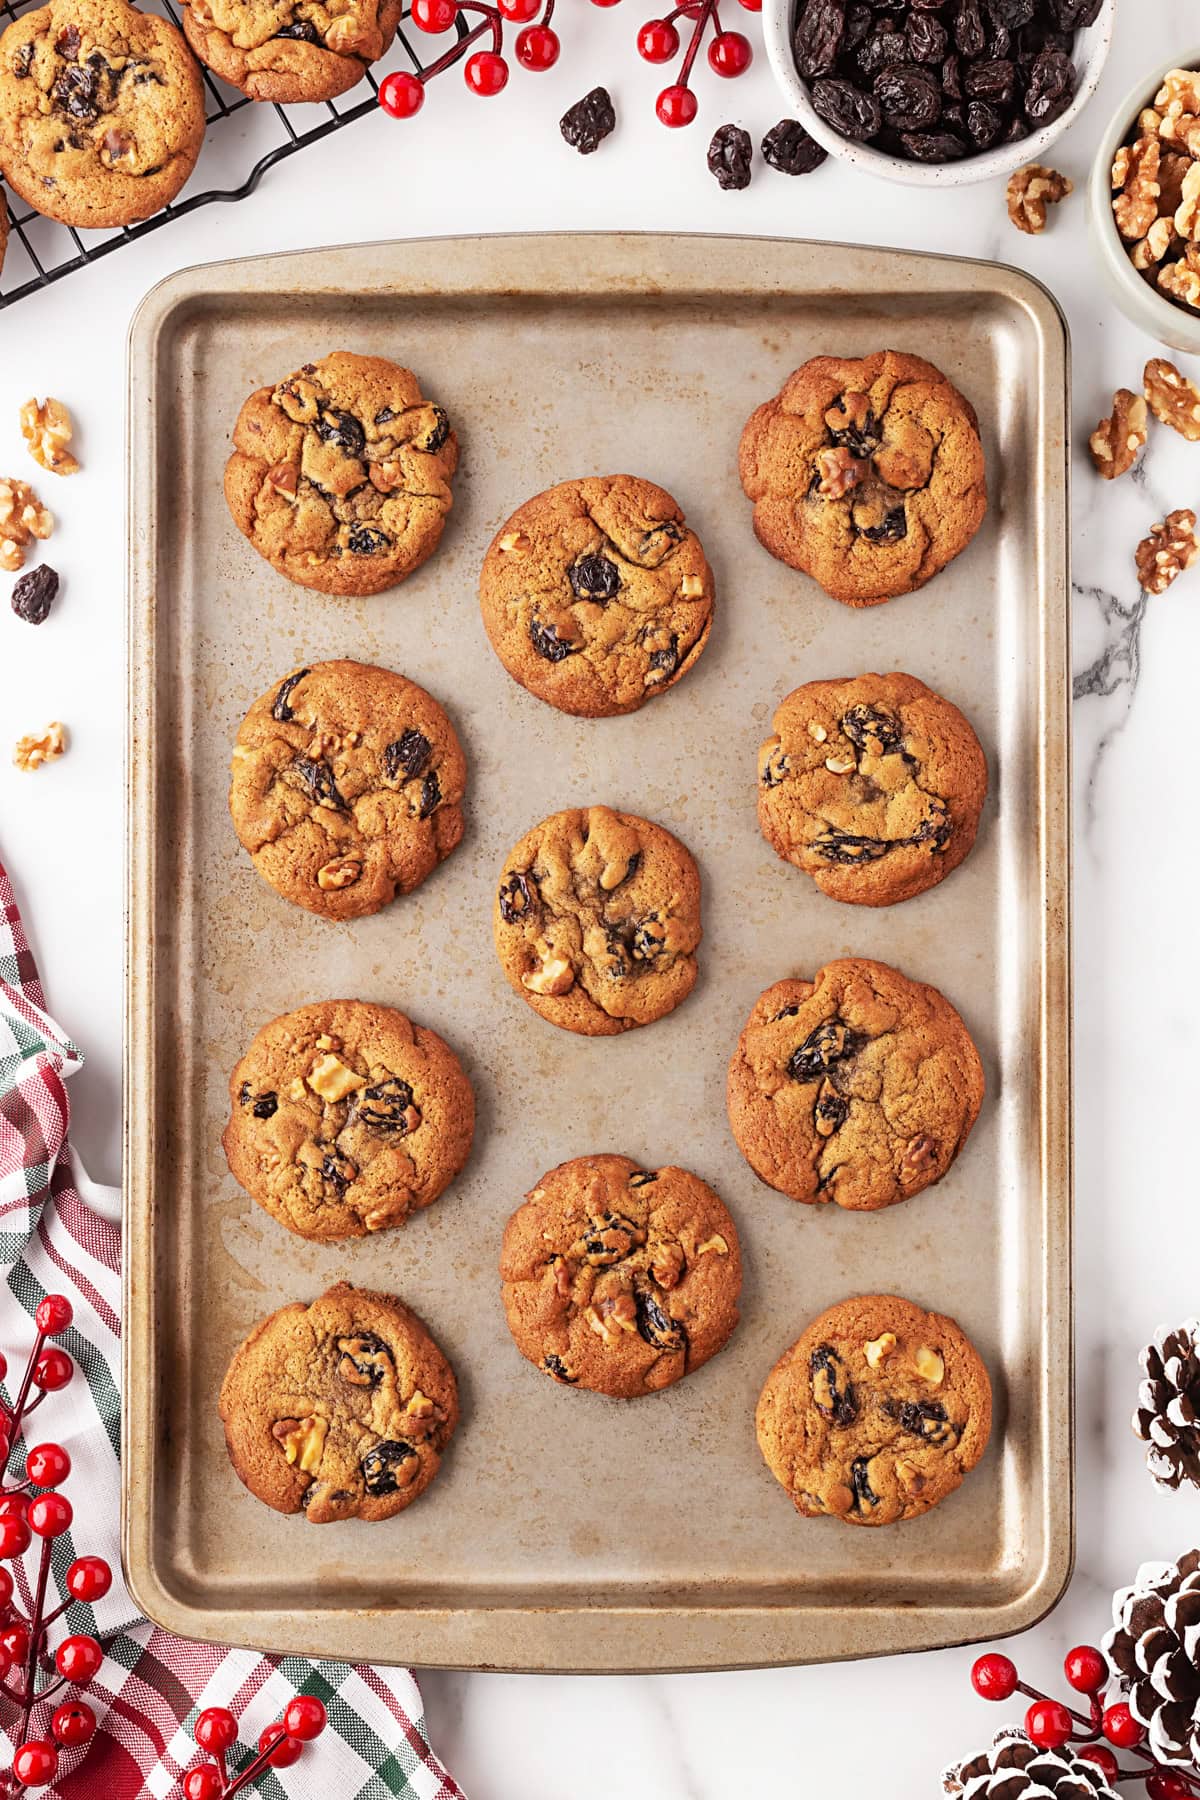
0,864 -> 462,1800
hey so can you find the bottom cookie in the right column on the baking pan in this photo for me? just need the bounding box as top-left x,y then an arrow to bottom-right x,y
756,1294 -> 991,1525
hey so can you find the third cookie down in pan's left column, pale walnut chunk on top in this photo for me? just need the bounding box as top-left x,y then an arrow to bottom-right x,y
221,1001 -> 475,1240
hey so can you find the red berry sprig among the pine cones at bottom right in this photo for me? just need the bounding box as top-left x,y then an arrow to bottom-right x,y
972,1643 -> 1200,1800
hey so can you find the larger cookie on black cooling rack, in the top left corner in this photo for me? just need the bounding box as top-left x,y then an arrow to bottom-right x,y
0,0 -> 205,229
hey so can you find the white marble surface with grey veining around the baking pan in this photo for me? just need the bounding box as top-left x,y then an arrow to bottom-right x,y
0,0 -> 1200,1800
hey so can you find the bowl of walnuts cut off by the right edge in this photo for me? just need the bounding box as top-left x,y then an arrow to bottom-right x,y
1088,49 -> 1200,355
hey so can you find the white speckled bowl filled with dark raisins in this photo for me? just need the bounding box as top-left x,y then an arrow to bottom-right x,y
763,0 -> 1115,187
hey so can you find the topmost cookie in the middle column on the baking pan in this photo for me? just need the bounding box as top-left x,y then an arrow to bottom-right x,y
479,475 -> 712,718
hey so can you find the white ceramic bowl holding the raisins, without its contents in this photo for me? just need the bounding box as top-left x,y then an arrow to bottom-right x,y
763,0 -> 1117,187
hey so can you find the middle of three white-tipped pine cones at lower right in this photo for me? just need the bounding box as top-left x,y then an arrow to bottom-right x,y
1101,1550 -> 1200,1768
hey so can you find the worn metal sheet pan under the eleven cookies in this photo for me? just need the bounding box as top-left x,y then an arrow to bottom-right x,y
124,234 -> 1072,1670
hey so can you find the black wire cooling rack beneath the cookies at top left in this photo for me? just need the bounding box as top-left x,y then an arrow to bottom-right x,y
0,0 -> 440,311
